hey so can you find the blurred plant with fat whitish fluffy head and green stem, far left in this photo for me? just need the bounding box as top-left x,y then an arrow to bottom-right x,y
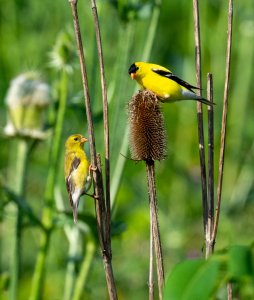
4,71 -> 50,300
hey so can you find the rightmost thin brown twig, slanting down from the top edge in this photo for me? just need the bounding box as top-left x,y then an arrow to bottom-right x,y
212,0 -> 233,247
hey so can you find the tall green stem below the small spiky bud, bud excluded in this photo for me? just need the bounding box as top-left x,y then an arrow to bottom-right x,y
30,70 -> 68,300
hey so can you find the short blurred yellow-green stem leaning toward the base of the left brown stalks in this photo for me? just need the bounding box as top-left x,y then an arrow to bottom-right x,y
72,239 -> 96,300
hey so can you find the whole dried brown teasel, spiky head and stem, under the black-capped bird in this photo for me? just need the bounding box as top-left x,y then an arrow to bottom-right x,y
128,90 -> 166,299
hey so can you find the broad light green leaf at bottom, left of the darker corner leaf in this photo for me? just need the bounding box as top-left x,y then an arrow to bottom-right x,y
163,259 -> 219,300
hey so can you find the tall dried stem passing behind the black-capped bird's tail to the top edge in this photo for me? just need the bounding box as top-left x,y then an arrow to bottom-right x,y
193,0 -> 208,233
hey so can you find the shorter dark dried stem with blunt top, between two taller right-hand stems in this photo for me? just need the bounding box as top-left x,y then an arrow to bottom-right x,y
206,73 -> 214,258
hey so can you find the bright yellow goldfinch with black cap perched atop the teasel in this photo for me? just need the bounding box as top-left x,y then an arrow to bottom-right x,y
129,62 -> 212,105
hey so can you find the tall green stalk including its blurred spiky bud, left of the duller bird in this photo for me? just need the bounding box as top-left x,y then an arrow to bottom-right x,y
29,27 -> 75,300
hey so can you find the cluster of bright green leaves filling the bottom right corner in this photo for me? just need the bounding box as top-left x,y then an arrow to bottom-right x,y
163,246 -> 254,300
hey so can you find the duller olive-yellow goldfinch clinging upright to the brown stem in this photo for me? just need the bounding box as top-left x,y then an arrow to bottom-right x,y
64,134 -> 91,223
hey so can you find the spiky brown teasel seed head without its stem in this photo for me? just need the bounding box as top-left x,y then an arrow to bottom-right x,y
128,90 -> 166,161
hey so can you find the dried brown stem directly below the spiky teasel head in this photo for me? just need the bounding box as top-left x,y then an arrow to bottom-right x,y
146,160 -> 164,300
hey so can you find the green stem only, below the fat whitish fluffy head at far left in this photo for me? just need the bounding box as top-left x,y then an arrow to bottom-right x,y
9,139 -> 28,300
